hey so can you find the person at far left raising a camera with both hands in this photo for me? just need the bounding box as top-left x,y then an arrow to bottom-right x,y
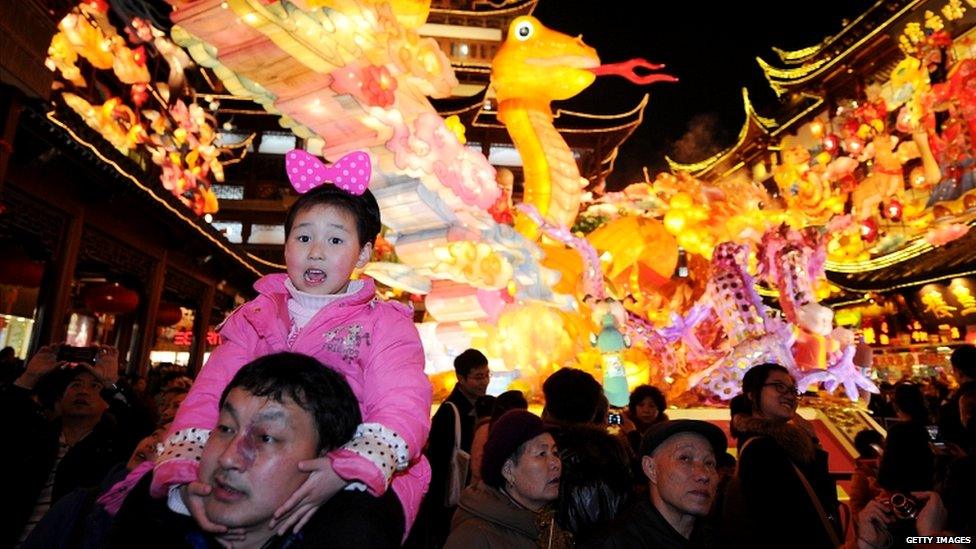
0,345 -> 152,547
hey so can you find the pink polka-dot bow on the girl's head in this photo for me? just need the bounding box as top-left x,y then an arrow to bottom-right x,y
285,149 -> 372,196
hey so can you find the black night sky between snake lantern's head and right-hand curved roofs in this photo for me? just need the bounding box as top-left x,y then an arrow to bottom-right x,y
533,0 -> 874,189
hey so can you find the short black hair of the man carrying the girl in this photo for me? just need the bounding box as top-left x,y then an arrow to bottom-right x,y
220,353 -> 362,451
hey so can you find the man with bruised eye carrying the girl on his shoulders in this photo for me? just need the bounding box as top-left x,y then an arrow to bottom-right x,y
109,353 -> 400,549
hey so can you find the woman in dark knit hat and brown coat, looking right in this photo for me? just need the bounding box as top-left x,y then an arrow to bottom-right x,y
444,410 -> 572,549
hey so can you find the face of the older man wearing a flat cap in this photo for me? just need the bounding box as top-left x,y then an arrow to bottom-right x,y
641,433 -> 718,517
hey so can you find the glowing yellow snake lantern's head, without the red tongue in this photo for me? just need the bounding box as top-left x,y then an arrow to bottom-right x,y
491,15 -> 600,103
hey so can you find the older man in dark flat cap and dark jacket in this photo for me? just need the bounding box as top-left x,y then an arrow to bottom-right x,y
580,419 -> 727,549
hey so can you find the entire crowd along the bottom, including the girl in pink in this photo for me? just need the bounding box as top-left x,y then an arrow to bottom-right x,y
0,158 -> 976,549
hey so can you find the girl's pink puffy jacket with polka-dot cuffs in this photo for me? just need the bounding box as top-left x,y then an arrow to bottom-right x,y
152,274 -> 432,531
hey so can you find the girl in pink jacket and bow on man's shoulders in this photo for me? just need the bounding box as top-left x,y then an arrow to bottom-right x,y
152,150 -> 432,533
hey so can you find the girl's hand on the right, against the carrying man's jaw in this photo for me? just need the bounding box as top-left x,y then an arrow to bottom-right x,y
269,457 -> 349,536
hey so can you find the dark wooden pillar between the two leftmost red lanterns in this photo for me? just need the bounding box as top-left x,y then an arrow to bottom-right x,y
34,210 -> 85,349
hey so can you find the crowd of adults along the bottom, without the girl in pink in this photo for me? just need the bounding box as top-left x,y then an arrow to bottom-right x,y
0,340 -> 976,549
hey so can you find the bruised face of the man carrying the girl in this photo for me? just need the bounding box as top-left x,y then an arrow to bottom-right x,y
199,388 -> 319,530
